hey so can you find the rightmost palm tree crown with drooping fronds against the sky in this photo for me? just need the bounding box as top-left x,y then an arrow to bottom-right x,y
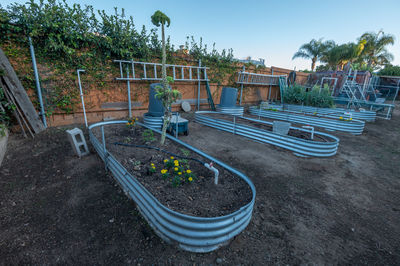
359,30 -> 395,68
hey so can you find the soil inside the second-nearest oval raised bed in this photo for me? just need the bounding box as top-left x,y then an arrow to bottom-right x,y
206,113 -> 329,142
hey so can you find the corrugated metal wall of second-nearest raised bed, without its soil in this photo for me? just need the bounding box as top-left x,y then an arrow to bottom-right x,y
195,111 -> 339,157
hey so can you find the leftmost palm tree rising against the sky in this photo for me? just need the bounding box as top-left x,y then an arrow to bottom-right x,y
292,38 -> 335,71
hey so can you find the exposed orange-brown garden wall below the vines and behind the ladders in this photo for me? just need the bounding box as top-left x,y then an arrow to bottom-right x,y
48,67 -> 308,126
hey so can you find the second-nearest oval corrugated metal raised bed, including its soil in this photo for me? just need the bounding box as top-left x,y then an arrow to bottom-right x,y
195,111 -> 339,157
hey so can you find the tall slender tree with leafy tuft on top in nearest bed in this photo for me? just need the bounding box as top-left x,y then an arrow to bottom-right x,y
151,10 -> 181,145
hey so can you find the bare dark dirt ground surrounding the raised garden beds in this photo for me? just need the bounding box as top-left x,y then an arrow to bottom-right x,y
0,103 -> 400,265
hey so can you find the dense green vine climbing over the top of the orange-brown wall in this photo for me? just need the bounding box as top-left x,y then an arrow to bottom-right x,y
0,0 -> 266,115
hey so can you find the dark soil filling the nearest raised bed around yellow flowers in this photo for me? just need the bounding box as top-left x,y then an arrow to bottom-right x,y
94,124 -> 252,217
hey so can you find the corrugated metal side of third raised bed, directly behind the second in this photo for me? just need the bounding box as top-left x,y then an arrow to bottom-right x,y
249,107 -> 365,135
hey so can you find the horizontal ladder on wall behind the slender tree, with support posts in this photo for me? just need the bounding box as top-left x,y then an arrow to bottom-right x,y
114,60 -> 215,117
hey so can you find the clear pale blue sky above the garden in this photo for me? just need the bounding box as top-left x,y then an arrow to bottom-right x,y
0,0 -> 400,70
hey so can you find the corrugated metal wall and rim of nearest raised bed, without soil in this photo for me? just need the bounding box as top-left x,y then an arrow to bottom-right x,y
89,120 -> 256,253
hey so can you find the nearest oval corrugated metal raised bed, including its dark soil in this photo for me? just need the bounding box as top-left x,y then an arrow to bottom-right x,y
89,121 -> 256,252
